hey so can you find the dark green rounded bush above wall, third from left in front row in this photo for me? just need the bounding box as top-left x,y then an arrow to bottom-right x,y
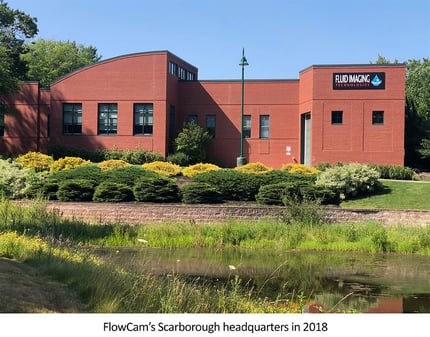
133,176 -> 179,202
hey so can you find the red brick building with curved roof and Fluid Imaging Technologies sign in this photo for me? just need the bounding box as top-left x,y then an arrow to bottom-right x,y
0,51 -> 405,168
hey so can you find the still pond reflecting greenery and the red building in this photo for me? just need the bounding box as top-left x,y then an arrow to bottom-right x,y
97,248 -> 430,313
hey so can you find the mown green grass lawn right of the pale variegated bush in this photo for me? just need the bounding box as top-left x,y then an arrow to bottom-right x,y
341,180 -> 430,210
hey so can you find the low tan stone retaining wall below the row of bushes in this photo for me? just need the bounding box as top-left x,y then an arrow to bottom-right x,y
48,202 -> 430,226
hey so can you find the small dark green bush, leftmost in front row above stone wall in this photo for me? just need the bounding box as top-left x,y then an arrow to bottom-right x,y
57,179 -> 96,201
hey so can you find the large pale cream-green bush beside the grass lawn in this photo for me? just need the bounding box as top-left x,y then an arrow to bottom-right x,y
316,163 -> 382,199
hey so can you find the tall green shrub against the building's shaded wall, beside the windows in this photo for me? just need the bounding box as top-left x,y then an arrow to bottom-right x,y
175,122 -> 212,164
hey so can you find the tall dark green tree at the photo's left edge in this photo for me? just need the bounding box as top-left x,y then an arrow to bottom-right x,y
0,0 -> 38,97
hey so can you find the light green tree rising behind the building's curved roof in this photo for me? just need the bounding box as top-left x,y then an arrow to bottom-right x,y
21,39 -> 101,87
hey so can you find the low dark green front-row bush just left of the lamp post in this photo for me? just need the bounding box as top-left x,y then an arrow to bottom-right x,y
181,183 -> 223,204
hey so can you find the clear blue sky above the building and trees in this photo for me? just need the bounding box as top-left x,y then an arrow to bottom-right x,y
6,0 -> 430,79
